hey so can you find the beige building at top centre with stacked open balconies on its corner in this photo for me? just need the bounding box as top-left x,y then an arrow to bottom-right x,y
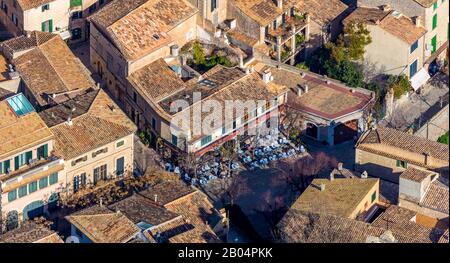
227,0 -> 310,63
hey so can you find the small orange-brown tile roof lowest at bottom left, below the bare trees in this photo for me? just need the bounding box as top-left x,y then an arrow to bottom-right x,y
66,208 -> 140,243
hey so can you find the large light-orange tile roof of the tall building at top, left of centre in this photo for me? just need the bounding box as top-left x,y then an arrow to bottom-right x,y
91,0 -> 198,60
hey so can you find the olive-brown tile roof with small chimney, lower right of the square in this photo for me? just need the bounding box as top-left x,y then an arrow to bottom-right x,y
292,178 -> 379,220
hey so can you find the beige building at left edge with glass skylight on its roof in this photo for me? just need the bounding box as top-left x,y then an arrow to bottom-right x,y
0,94 -> 65,229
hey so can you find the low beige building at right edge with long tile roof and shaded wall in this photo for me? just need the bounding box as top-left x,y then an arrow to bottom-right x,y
355,127 -> 449,183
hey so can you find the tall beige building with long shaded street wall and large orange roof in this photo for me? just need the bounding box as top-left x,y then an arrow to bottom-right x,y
90,0 -> 198,127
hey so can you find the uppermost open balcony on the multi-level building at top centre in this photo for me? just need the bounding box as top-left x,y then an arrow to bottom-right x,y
265,15 -> 309,45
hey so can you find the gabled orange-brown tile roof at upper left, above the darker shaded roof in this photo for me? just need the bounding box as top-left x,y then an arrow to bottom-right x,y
14,37 -> 95,106
